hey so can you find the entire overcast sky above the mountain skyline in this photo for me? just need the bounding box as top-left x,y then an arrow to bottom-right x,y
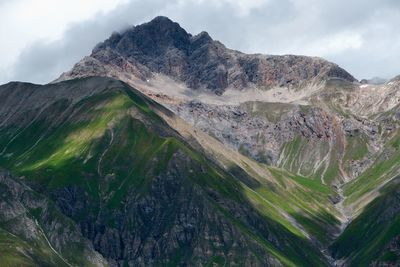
0,0 -> 400,84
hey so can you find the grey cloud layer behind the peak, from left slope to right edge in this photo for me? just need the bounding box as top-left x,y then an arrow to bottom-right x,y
8,0 -> 400,82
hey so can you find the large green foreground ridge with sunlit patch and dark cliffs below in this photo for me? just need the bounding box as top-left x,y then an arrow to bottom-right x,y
0,78 -> 335,266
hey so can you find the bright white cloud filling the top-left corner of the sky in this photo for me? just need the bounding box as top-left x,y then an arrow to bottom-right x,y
0,0 -> 126,81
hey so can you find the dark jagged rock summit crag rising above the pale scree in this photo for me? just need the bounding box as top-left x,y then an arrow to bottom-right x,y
60,17 -> 355,94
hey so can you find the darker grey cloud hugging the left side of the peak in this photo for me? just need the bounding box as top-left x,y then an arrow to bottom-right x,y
12,1 -> 170,83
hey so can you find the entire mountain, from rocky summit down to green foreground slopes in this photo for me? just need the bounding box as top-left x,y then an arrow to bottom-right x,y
0,17 -> 400,266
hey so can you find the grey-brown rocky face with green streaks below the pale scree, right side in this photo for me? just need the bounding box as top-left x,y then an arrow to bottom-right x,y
167,78 -> 400,187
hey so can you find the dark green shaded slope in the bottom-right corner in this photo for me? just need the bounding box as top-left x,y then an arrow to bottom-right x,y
331,178 -> 400,266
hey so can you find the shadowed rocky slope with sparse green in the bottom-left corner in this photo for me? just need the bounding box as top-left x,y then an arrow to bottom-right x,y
0,171 -> 104,266
